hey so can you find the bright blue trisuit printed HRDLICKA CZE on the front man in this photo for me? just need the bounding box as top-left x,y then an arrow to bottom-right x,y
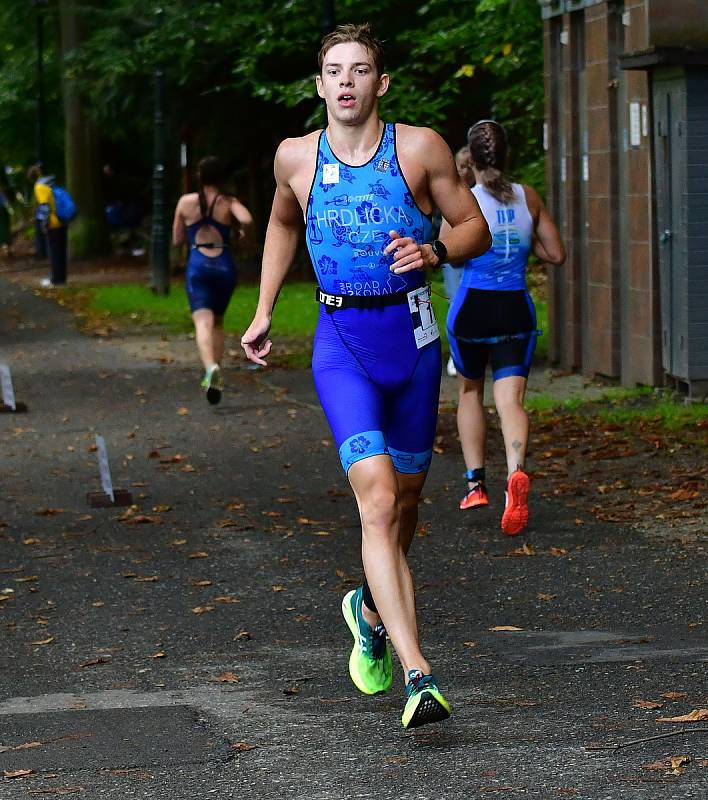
305,124 -> 440,473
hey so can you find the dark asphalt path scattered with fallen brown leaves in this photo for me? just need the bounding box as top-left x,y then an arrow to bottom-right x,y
0,282 -> 708,800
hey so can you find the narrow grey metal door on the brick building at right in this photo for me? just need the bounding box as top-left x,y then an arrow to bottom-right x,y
653,73 -> 688,378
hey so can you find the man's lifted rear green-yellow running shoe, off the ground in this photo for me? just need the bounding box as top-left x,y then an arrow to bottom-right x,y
342,586 -> 393,694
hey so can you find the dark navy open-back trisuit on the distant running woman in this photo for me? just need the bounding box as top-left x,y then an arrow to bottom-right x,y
185,195 -> 236,317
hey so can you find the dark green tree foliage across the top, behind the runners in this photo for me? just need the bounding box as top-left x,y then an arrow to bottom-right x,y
0,0 -> 543,225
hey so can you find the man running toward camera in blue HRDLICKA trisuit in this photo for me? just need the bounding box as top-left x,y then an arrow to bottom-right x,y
242,25 -> 491,728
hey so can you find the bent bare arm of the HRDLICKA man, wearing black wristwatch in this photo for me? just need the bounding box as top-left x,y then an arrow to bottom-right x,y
384,128 -> 491,273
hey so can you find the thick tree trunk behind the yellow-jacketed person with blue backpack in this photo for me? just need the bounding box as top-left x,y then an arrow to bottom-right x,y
59,0 -> 110,258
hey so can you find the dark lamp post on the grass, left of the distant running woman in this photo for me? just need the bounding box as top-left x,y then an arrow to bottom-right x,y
151,68 -> 170,295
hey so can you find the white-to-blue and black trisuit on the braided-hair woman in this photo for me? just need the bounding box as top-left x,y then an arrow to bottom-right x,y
447,183 -> 538,380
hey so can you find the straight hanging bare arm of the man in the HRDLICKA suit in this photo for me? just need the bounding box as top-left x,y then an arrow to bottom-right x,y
241,139 -> 303,366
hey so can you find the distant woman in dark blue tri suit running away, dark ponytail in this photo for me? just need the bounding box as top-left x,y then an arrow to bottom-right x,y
172,156 -> 253,405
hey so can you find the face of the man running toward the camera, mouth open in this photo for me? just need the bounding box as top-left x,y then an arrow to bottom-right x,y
317,42 -> 388,125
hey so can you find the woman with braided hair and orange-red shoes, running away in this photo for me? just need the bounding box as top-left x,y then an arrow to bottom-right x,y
448,120 -> 565,536
